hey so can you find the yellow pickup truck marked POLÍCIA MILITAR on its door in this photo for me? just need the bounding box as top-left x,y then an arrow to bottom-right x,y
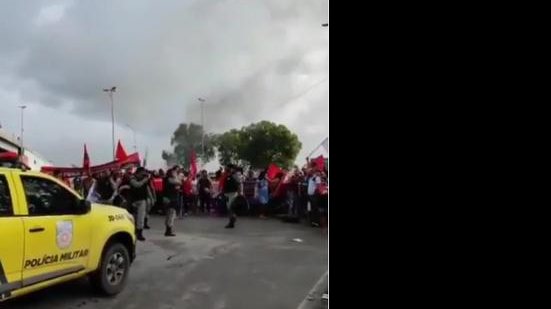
0,167 -> 136,302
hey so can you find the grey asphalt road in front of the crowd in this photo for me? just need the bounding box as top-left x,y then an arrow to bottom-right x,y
4,217 -> 328,309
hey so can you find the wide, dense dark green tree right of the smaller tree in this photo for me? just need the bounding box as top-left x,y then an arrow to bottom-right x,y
217,121 -> 302,168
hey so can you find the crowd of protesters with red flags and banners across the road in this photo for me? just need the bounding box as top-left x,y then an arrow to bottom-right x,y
57,160 -> 328,240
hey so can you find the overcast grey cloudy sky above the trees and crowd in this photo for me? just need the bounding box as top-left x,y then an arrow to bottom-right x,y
0,0 -> 329,167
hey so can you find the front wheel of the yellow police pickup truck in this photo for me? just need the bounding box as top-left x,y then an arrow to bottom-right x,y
90,243 -> 130,296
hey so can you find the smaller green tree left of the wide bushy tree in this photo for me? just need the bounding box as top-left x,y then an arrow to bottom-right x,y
161,123 -> 216,167
